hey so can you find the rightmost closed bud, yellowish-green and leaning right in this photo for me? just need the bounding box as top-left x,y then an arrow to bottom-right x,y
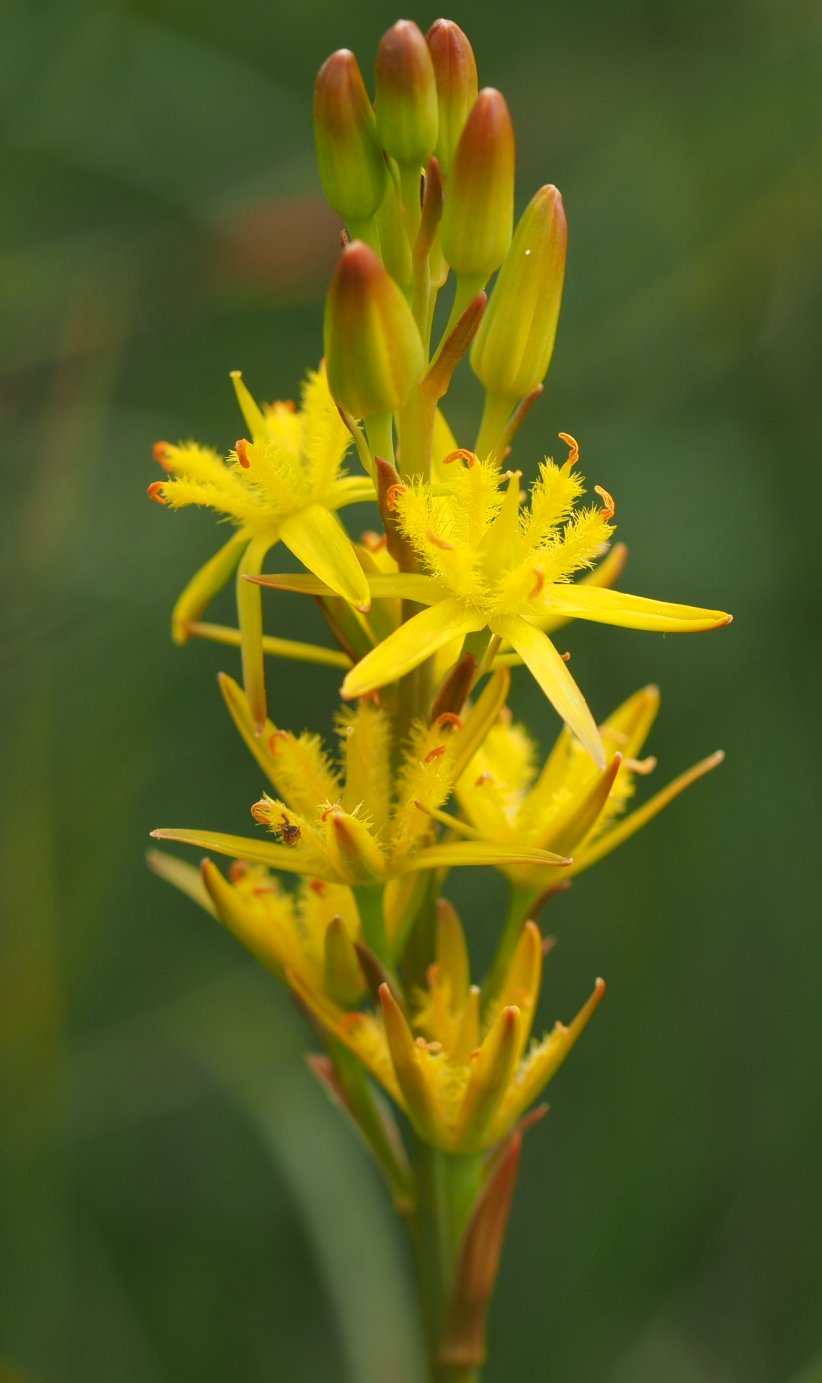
471,185 -> 567,402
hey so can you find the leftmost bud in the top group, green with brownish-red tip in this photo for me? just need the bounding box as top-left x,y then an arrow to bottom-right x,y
314,48 -> 387,223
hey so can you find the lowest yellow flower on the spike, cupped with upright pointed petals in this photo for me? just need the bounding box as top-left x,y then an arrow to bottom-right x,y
288,904 -> 605,1152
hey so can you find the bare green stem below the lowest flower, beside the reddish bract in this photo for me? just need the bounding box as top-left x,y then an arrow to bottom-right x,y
414,1140 -> 483,1383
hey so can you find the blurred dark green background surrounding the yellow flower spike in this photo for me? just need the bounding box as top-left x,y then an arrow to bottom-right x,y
0,0 -> 822,1383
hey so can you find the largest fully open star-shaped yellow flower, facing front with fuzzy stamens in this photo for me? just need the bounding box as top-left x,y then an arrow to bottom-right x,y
336,438 -> 731,769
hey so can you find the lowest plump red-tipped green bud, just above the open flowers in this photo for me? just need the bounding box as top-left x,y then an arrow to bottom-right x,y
325,241 -> 425,418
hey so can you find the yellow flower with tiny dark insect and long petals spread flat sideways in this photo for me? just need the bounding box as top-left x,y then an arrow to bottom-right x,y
152,674 -> 569,956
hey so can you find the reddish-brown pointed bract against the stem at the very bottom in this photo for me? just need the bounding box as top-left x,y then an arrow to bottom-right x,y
437,1133 -> 522,1376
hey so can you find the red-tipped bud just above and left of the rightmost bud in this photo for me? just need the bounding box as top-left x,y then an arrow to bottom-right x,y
440,87 -> 515,284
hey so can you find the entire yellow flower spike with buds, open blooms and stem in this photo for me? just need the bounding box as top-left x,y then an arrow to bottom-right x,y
143,19 -> 731,1377
